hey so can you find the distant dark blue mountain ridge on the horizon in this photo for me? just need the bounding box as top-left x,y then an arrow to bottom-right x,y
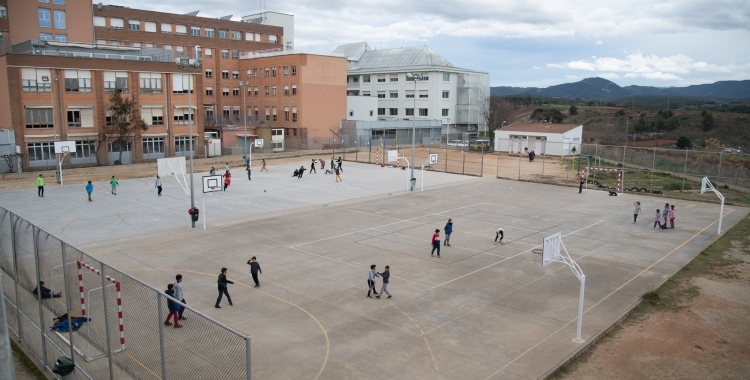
490,78 -> 750,100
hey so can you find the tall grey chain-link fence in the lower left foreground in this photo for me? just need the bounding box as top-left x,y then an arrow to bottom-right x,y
0,208 -> 250,379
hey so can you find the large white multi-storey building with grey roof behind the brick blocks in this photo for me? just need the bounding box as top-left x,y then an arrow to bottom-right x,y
335,42 -> 490,137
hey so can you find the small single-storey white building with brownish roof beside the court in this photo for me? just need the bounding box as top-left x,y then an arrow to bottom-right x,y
495,123 -> 583,156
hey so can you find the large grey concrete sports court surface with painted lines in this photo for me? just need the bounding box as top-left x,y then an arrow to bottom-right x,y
0,160 -> 748,380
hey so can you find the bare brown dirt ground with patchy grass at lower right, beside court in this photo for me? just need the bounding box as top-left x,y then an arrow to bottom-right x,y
553,217 -> 750,379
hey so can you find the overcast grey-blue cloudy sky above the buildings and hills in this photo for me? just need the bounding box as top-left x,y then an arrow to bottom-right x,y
122,0 -> 750,87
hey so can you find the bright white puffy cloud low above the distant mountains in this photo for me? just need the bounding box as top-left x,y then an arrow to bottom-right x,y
547,53 -> 739,80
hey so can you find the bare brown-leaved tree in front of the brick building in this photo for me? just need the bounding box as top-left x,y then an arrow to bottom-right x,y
103,91 -> 148,163
